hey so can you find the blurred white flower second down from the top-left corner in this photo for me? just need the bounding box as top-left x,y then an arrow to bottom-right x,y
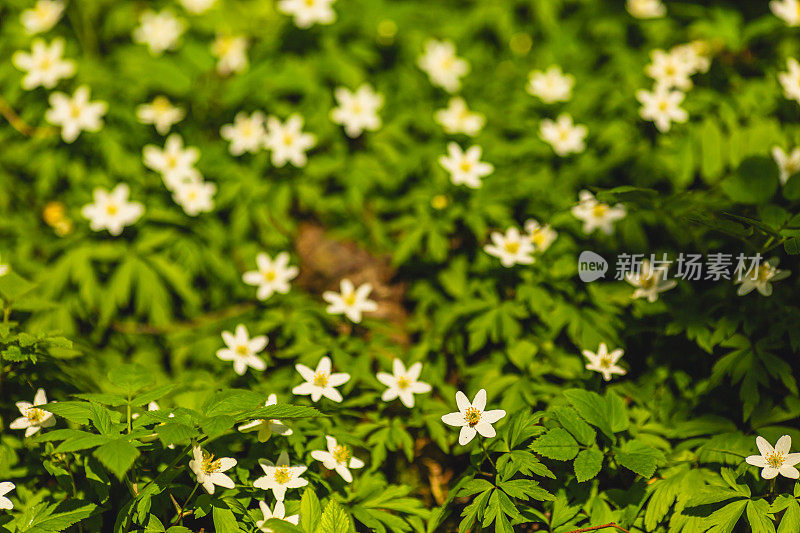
11,37 -> 75,91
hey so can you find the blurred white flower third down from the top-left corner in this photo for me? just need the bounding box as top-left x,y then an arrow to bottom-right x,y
44,85 -> 108,143
